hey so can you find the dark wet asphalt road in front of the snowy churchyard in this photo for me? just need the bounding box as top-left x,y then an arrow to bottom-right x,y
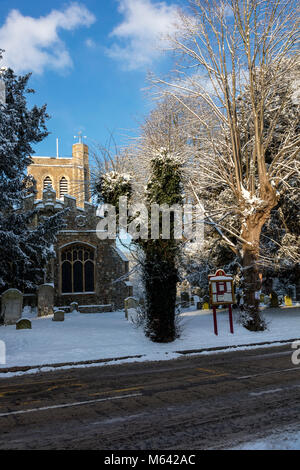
0,345 -> 300,450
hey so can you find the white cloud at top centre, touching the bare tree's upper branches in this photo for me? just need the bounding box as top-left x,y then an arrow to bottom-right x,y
107,0 -> 179,70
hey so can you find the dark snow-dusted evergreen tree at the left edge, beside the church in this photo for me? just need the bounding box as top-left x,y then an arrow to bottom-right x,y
0,51 -> 63,291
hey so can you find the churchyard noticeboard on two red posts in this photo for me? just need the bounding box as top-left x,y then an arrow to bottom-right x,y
208,269 -> 235,335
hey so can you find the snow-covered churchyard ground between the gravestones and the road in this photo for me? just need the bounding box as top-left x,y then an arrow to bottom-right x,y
0,307 -> 300,377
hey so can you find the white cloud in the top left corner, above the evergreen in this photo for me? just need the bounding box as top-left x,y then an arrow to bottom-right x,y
0,3 -> 96,74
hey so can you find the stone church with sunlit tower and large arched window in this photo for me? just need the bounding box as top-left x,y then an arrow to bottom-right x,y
24,142 -> 132,312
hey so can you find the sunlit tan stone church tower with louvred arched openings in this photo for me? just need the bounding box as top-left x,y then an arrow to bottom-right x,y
28,139 -> 90,207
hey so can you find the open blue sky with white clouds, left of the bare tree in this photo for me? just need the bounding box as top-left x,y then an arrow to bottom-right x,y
0,0 -> 185,160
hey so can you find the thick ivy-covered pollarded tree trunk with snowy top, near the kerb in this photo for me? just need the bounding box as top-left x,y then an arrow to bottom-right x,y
135,149 -> 183,342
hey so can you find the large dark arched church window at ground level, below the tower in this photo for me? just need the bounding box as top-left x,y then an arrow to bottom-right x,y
61,244 -> 95,294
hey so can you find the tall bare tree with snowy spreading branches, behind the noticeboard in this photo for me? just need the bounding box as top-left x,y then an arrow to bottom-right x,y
152,0 -> 299,330
